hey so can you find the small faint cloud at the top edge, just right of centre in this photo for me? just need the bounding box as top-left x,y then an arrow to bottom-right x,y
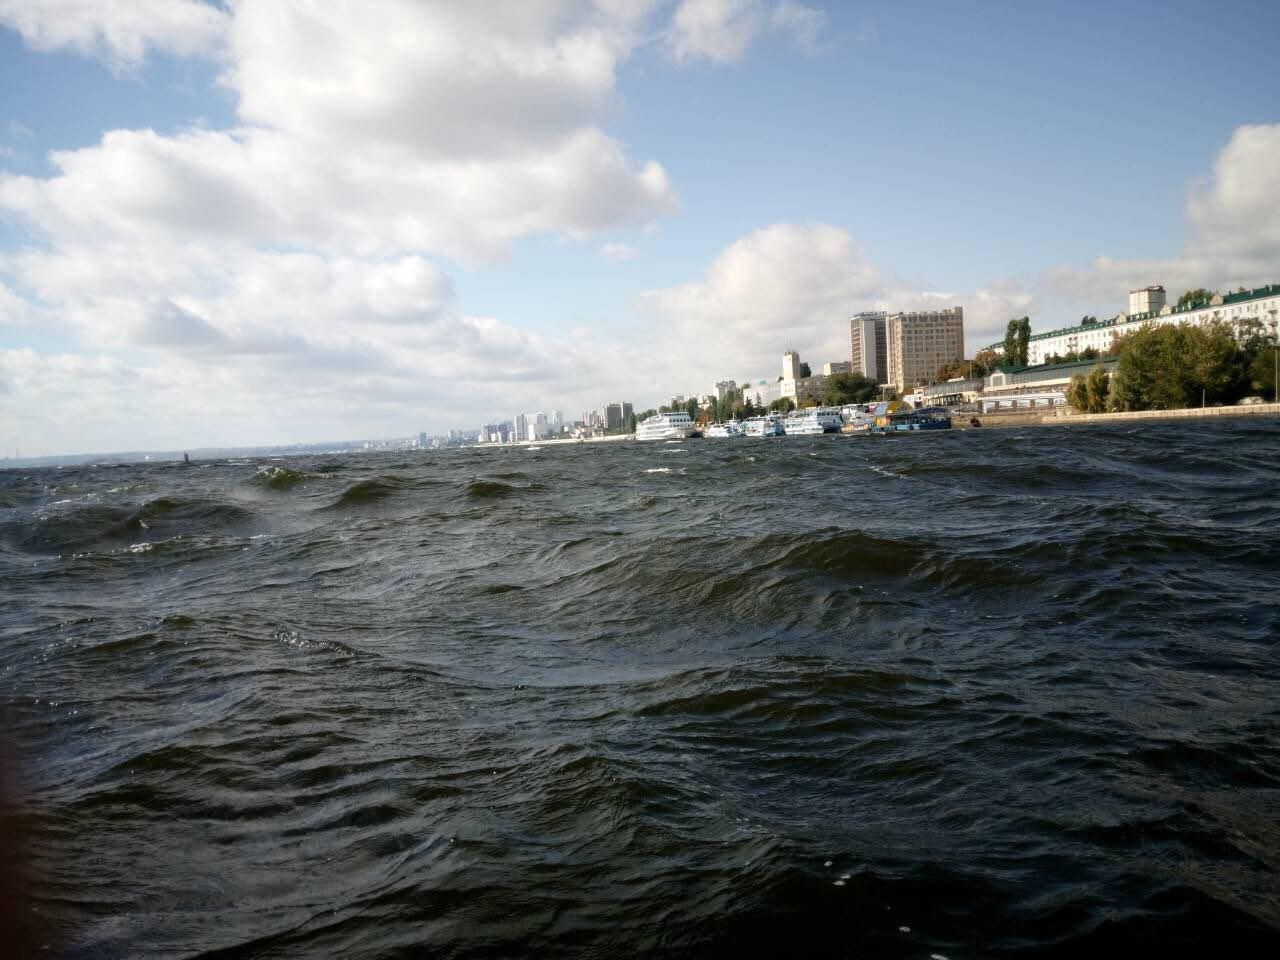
667,0 -> 826,64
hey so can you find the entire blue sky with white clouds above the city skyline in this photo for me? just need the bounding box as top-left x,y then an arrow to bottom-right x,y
0,0 -> 1280,456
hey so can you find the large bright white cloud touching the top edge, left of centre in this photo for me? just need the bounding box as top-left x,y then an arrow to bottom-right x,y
224,0 -> 646,159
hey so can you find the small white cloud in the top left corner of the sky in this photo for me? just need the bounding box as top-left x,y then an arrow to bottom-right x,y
0,0 -> 228,68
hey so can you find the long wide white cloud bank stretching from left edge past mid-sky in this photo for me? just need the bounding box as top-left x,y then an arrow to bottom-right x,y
0,117 -> 677,260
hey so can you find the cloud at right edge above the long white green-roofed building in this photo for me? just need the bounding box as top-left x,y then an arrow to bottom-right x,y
1042,124 -> 1280,302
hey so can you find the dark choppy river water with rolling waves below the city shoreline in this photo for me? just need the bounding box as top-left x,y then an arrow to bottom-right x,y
0,420 -> 1280,960
